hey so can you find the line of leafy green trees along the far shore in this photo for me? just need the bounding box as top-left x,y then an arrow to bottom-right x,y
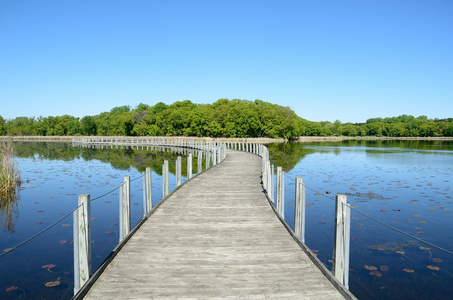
0,99 -> 453,140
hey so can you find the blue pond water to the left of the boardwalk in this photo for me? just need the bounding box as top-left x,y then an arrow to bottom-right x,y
0,142 -> 196,299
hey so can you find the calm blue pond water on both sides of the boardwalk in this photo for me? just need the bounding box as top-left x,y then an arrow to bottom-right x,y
0,142 -> 453,299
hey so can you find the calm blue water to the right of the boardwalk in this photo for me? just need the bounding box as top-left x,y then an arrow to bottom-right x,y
269,142 -> 453,299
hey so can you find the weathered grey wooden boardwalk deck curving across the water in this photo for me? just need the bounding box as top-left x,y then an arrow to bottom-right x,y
81,150 -> 348,300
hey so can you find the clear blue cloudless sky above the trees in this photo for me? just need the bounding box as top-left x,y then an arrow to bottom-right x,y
0,0 -> 453,123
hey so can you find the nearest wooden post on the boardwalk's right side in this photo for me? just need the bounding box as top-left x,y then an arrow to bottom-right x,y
333,194 -> 351,289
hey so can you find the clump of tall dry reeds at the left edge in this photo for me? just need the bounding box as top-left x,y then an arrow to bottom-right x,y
0,140 -> 21,202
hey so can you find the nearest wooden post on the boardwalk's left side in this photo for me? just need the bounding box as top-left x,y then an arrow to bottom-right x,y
74,194 -> 91,293
